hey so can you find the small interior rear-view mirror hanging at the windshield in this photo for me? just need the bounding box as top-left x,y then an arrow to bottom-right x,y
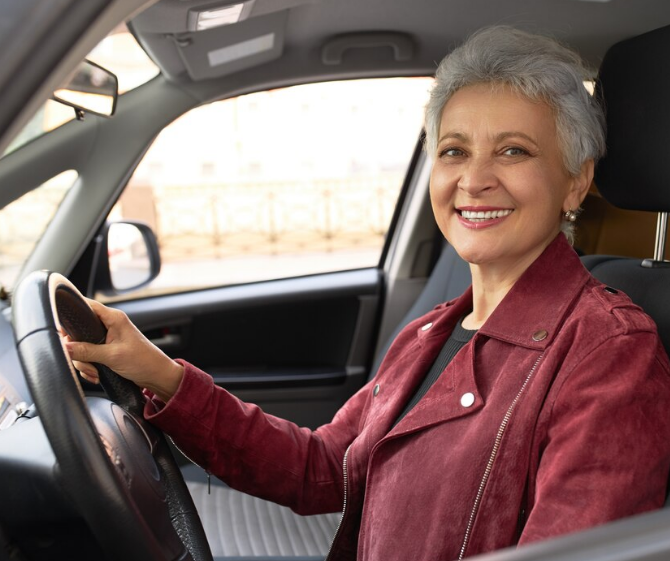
53,60 -> 119,117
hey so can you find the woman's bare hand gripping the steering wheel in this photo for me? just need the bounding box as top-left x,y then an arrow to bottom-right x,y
65,300 -> 184,401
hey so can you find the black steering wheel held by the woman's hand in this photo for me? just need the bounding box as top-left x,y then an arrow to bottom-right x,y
12,271 -> 212,561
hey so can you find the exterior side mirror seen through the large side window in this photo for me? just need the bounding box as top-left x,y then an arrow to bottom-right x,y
94,220 -> 161,296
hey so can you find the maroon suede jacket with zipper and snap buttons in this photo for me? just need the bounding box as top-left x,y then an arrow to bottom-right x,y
145,235 -> 670,561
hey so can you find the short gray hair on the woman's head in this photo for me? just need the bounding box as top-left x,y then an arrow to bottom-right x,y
424,26 -> 605,238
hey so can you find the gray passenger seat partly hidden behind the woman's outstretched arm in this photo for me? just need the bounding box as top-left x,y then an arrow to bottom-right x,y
182,245 -> 470,561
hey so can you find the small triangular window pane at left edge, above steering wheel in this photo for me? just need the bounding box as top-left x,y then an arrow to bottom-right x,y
0,170 -> 78,289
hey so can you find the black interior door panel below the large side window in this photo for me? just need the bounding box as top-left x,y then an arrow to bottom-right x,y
116,269 -> 382,427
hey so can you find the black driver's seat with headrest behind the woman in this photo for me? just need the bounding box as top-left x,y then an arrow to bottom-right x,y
582,26 -> 670,350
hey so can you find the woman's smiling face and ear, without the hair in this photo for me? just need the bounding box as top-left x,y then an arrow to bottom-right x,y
430,84 -> 593,270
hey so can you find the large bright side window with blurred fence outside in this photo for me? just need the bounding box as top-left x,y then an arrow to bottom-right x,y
110,78 -> 431,297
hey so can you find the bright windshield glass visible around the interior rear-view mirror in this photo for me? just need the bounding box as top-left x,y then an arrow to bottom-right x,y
3,24 -> 158,155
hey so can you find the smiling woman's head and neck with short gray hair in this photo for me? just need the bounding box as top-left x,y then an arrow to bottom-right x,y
426,27 -> 605,328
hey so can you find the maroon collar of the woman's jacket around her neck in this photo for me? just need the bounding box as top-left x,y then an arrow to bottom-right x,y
417,234 -> 589,350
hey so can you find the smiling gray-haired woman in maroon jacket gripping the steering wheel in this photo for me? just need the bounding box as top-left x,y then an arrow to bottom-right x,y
68,27 -> 670,561
